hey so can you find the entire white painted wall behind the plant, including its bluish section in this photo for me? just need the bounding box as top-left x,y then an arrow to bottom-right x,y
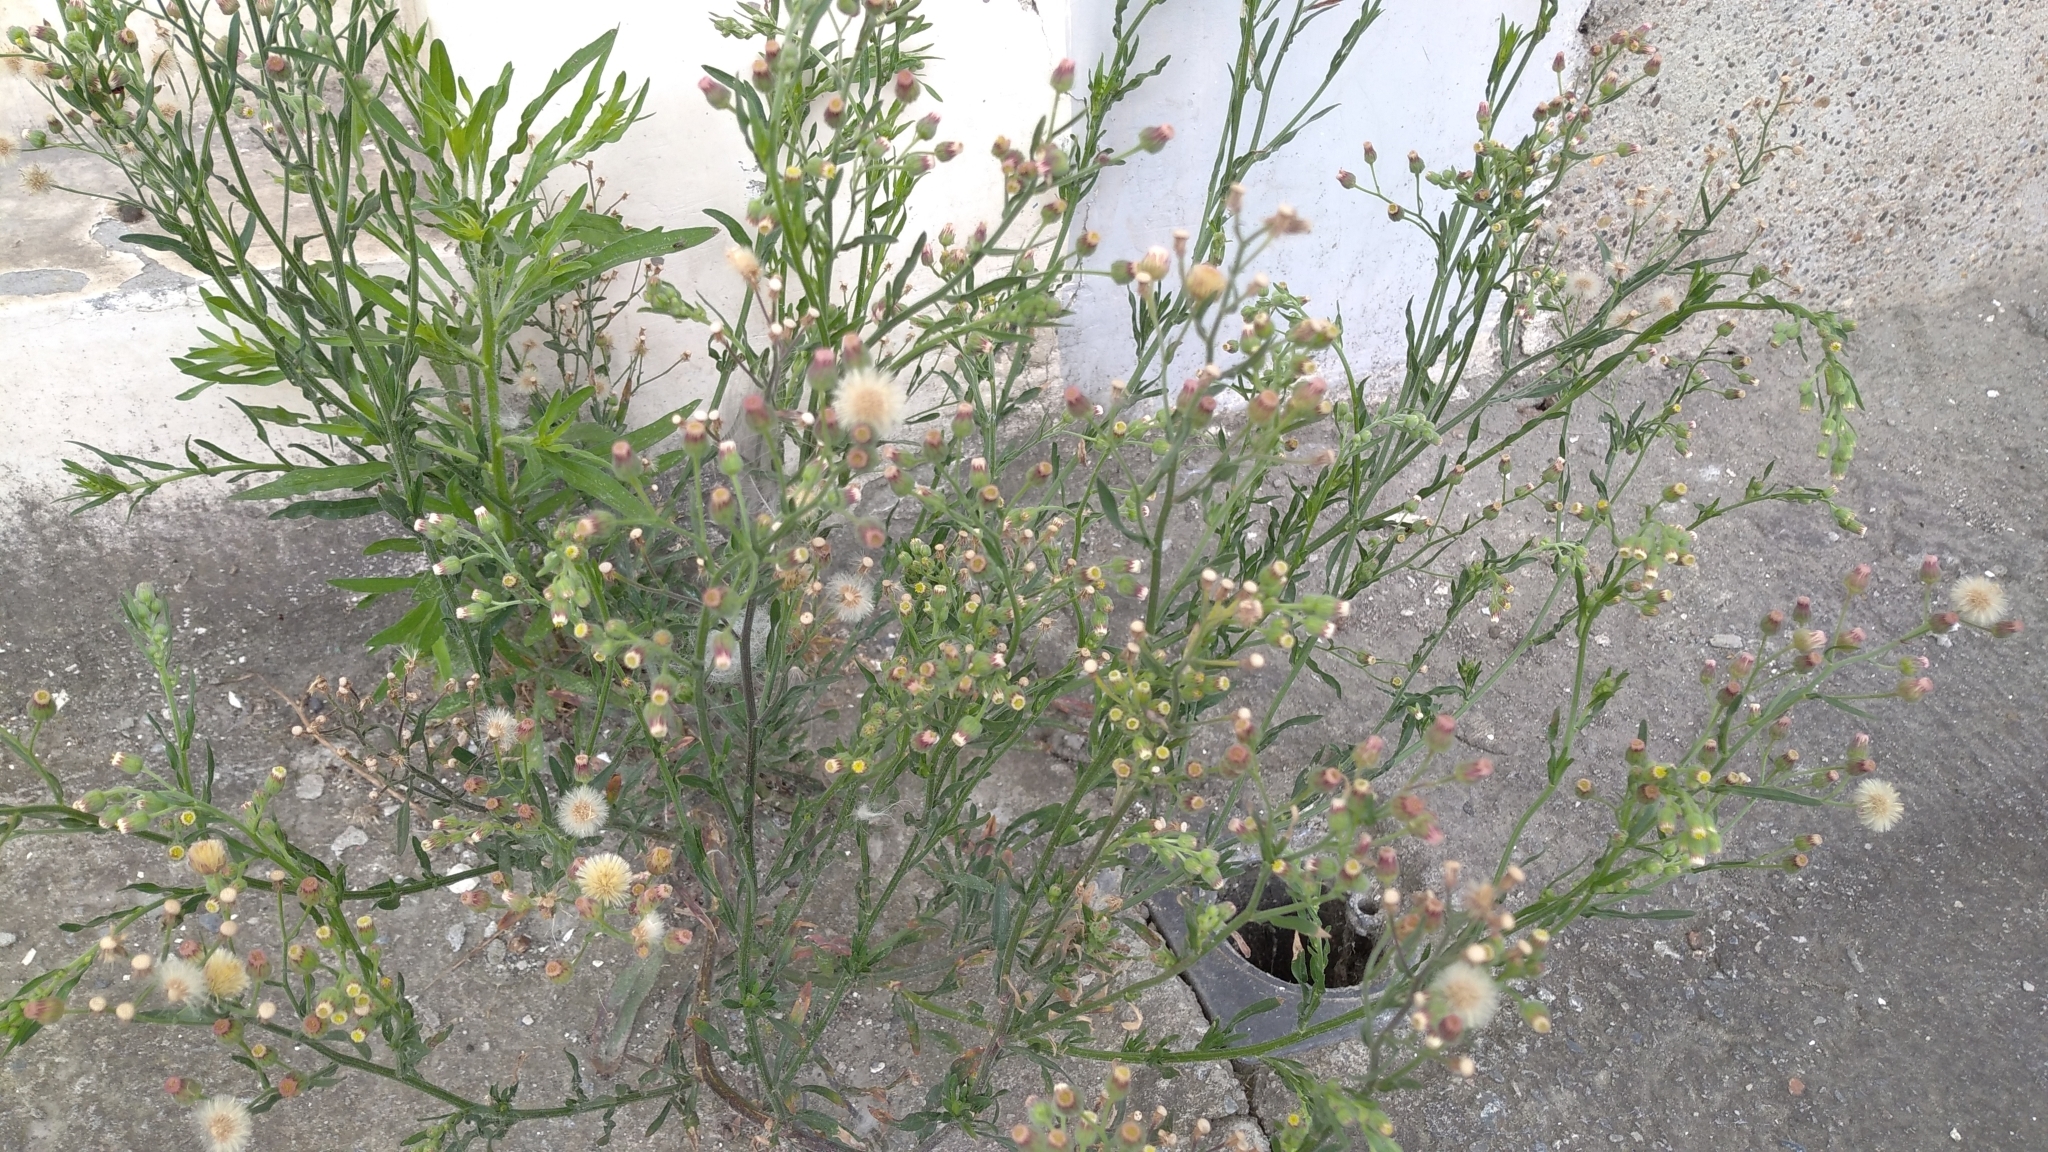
0,0 -> 1587,496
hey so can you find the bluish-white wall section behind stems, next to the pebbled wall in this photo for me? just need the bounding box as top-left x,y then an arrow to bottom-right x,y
1061,0 -> 1589,389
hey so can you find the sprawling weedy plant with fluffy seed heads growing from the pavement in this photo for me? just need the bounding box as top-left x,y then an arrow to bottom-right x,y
0,0 -> 2017,1148
